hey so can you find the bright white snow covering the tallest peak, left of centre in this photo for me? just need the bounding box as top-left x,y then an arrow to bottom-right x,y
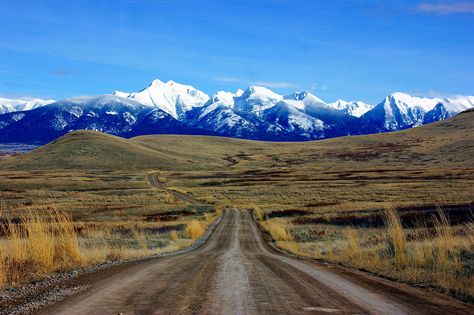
113,80 -> 209,120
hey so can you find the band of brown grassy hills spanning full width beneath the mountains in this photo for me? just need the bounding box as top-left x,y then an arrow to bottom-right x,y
0,111 -> 474,170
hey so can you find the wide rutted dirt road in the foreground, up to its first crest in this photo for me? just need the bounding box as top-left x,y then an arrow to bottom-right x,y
44,209 -> 474,314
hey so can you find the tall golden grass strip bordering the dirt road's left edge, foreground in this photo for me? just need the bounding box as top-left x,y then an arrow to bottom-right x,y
0,208 -> 217,287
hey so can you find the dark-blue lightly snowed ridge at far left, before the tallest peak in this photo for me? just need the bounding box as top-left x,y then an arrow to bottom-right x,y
0,95 -> 208,143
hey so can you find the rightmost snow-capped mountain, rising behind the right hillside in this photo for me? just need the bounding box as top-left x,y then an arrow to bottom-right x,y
361,92 -> 474,132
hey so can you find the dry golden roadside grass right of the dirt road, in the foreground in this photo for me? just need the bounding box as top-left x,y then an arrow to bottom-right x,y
259,207 -> 474,300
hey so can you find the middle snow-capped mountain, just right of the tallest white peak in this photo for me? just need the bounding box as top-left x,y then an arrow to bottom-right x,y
188,86 -> 362,140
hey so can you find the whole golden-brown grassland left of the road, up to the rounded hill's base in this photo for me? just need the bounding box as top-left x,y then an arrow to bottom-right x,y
0,170 -> 217,287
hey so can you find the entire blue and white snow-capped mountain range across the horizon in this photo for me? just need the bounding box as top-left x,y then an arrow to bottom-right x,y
0,80 -> 474,144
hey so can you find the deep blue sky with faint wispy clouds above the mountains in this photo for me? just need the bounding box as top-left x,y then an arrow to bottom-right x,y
0,0 -> 474,103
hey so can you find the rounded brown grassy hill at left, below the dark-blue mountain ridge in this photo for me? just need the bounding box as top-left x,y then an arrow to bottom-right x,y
0,130 -> 218,171
